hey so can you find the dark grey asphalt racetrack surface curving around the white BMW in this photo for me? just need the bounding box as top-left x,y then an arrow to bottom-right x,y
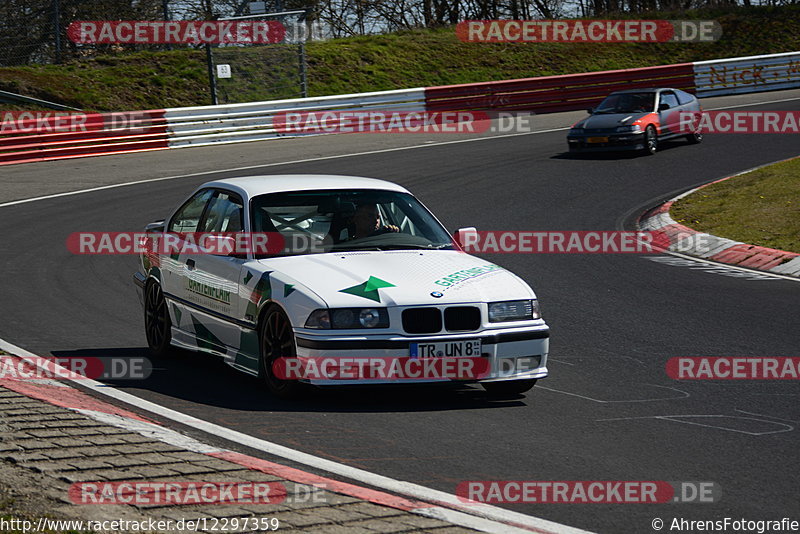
0,97 -> 800,533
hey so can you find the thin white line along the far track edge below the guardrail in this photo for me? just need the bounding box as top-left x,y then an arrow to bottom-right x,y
0,128 -> 569,208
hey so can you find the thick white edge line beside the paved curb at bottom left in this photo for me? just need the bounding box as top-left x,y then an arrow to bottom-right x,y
0,339 -> 591,534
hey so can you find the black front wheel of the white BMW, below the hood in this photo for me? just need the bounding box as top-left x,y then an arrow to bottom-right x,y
258,306 -> 302,399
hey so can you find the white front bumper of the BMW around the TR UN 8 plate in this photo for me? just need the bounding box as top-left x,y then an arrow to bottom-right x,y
296,325 -> 550,386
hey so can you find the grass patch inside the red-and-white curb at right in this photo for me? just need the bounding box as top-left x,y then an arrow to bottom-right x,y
670,158 -> 800,253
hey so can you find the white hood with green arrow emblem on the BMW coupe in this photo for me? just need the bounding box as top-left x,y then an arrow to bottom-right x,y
261,250 -> 535,307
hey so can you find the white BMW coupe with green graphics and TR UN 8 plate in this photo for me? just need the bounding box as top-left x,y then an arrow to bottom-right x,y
134,175 -> 550,397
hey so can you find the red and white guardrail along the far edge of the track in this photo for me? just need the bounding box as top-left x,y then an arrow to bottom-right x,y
0,52 -> 800,165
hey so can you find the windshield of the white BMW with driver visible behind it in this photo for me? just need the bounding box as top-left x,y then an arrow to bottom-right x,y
251,190 -> 455,256
